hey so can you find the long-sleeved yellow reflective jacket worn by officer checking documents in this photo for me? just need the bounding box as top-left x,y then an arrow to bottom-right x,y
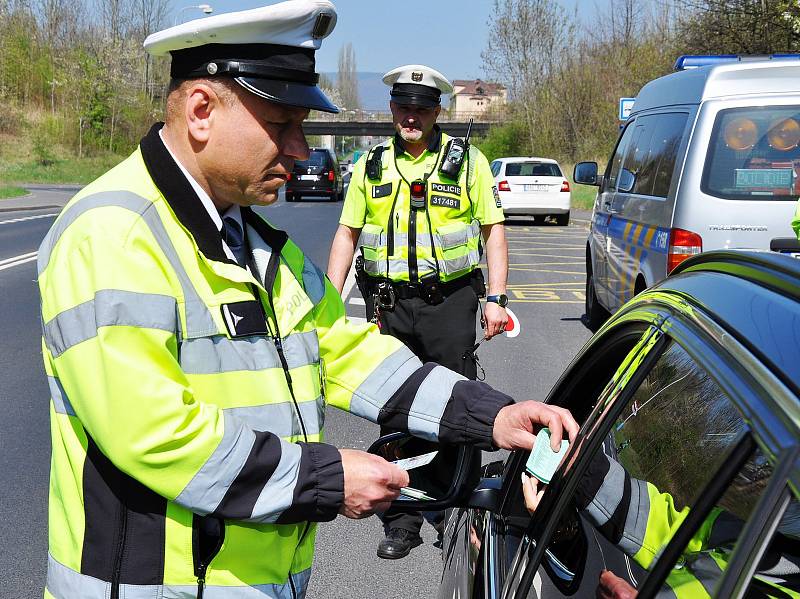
38,126 -> 510,599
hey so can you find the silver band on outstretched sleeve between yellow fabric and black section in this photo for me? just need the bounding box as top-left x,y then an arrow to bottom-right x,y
350,345 -> 422,422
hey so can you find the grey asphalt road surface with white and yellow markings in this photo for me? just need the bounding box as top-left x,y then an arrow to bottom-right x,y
0,187 -> 590,599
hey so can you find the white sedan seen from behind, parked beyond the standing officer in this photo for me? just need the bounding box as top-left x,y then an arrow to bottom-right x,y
492,156 -> 570,226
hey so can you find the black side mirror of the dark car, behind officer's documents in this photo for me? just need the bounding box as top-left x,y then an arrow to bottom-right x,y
367,432 -> 480,512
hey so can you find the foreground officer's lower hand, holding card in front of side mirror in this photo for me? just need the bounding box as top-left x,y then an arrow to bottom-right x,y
339,449 -> 409,518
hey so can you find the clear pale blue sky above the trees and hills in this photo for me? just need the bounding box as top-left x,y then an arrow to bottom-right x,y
172,0 -> 579,80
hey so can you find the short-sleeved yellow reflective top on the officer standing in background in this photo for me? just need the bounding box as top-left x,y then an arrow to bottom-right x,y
339,128 -> 504,282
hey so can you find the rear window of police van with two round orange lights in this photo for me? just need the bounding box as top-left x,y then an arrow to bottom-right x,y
701,106 -> 800,201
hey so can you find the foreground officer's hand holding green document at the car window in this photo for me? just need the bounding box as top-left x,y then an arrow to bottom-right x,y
492,401 -> 578,451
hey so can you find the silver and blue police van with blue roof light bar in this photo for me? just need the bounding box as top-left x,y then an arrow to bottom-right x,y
574,55 -> 800,330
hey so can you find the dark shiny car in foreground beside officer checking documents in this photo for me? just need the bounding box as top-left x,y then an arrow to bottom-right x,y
374,251 -> 800,599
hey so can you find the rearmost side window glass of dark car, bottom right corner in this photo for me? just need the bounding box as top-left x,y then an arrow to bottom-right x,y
745,491 -> 800,597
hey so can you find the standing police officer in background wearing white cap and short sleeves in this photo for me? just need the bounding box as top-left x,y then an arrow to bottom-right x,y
328,65 -> 508,558
